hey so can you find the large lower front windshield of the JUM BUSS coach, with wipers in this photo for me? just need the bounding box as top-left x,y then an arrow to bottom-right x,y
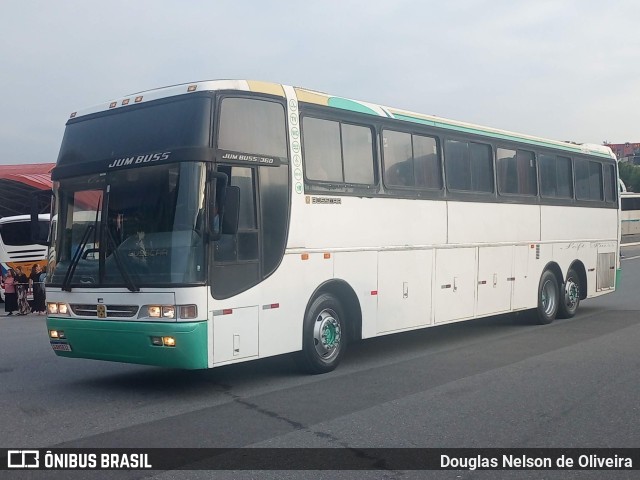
49,162 -> 206,290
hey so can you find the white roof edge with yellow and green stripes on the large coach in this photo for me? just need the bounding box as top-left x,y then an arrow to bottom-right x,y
71,80 -> 616,160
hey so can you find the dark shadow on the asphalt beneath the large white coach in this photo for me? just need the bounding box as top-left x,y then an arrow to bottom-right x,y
76,312 -> 535,399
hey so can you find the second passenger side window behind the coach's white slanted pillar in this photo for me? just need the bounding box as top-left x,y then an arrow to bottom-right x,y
383,130 -> 442,189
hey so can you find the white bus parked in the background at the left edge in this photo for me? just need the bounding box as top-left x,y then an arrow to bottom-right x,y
0,214 -> 49,301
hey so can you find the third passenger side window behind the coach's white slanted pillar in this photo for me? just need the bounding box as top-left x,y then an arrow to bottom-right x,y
445,140 -> 493,193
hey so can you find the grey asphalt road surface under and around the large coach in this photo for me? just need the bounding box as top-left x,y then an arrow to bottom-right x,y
0,247 -> 640,479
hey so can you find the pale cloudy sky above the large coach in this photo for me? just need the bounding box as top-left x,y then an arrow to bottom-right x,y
0,0 -> 640,164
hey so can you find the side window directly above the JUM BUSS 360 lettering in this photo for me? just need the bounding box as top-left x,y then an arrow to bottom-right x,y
218,98 -> 287,158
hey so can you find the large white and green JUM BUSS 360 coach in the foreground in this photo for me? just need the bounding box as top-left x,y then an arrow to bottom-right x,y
41,80 -> 620,373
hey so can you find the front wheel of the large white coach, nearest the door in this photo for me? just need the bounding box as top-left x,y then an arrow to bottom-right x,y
302,293 -> 347,374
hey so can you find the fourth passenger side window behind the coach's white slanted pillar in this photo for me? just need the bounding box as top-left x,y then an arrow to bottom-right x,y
497,148 -> 538,195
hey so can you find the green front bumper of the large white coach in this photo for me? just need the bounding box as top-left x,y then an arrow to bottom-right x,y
47,317 -> 208,369
